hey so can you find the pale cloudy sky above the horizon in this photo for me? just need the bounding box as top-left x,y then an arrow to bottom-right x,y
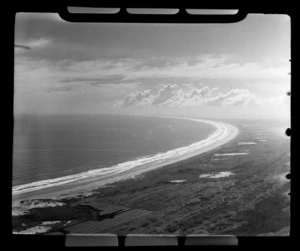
14,13 -> 290,119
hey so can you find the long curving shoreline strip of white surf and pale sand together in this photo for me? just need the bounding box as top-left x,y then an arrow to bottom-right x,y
13,116 -> 239,204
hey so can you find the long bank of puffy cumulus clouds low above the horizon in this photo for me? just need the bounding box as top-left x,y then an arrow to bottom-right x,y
114,84 -> 282,107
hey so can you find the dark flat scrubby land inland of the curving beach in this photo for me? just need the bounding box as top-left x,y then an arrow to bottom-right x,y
13,121 -> 290,236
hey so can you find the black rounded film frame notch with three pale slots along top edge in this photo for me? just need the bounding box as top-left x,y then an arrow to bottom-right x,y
58,6 -> 247,23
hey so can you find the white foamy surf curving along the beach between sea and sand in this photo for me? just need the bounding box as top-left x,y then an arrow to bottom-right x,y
12,117 -> 239,195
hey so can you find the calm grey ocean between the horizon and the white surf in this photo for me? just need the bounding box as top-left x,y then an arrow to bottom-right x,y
13,115 -> 215,187
